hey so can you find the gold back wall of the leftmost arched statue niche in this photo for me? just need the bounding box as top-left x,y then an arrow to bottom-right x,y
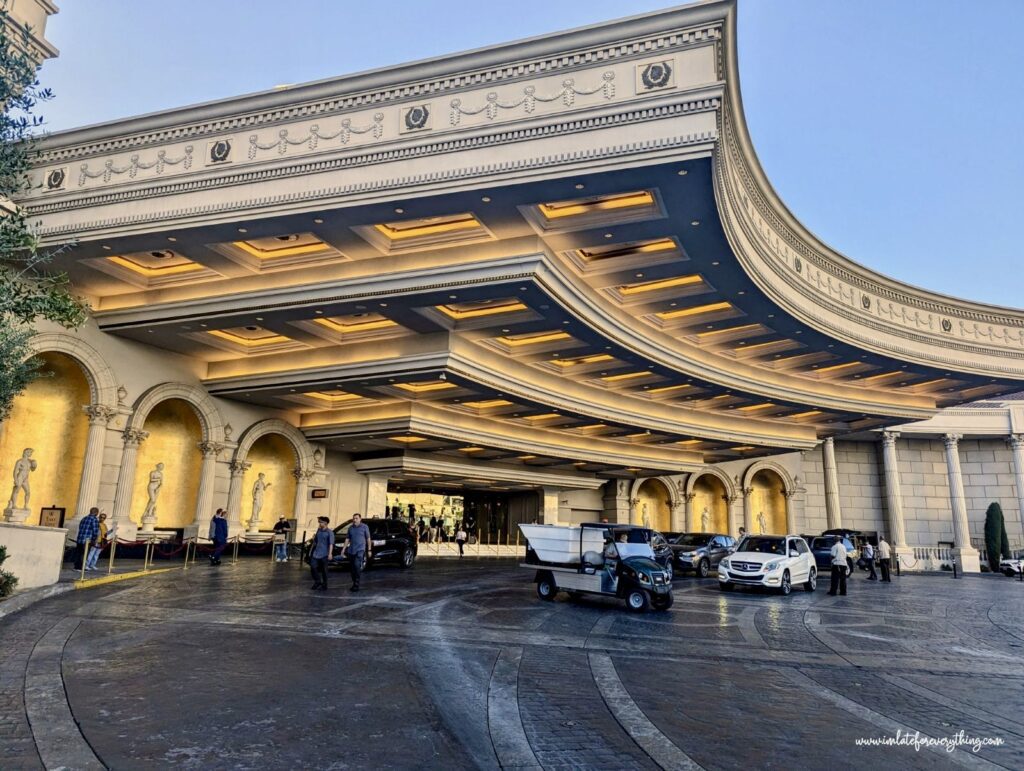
0,352 -> 90,524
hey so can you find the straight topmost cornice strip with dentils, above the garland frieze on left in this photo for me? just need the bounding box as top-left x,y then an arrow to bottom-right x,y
28,0 -> 733,163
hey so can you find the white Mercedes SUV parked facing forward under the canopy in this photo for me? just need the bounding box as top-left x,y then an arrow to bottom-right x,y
718,536 -> 818,594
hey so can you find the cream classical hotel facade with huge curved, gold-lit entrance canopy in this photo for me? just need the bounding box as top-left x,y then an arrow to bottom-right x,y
6,2 -> 1024,569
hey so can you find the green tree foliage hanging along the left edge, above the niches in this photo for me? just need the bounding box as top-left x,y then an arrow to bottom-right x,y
0,8 -> 86,420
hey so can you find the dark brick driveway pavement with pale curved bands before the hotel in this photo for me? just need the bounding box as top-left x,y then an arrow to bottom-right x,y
0,559 -> 1024,771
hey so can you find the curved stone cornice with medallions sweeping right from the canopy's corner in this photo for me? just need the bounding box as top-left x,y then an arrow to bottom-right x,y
715,3 -> 1024,378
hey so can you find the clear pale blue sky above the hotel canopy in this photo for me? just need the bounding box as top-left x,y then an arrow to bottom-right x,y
34,0 -> 1024,307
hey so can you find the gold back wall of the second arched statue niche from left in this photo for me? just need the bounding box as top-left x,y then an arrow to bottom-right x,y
131,399 -> 203,529
